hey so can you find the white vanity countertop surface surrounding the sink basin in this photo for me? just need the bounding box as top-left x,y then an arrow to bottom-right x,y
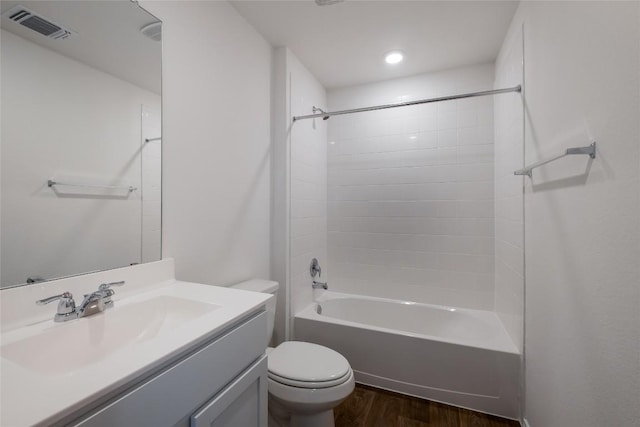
0,272 -> 272,427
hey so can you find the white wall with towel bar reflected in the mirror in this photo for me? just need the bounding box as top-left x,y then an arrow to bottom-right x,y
2,31 -> 160,285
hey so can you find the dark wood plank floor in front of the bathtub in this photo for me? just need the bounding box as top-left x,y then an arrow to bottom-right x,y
334,384 -> 520,427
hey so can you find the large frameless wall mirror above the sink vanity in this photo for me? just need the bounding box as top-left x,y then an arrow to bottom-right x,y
0,0 -> 161,288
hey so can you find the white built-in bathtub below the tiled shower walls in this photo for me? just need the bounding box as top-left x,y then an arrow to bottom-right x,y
294,292 -> 520,419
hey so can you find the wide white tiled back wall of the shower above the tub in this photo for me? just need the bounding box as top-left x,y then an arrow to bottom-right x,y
327,64 -> 494,309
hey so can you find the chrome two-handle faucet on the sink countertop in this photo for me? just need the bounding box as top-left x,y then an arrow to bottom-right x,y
36,280 -> 125,322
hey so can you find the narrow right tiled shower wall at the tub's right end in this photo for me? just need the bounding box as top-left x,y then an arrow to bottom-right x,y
494,25 -> 524,354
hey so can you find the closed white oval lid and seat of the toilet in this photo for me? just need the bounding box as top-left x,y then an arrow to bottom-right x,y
268,341 -> 351,388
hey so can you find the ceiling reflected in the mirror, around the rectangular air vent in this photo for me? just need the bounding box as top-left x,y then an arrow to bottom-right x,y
2,0 -> 162,93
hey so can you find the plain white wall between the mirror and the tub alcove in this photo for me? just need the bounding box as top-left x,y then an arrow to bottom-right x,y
140,0 -> 272,285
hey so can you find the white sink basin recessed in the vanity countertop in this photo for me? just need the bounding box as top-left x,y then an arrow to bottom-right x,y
0,295 -> 220,375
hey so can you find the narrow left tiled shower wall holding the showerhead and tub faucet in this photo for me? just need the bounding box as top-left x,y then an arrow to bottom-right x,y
287,51 -> 328,328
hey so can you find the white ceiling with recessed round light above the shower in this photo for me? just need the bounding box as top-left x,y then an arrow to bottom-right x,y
231,0 -> 518,89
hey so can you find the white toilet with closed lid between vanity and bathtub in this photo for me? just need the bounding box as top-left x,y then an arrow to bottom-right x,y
233,280 -> 355,427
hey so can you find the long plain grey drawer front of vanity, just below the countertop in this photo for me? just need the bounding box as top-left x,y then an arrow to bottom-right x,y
76,312 -> 267,427
